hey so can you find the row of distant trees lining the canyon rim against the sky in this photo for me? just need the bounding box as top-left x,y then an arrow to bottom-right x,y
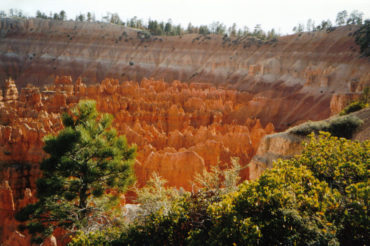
0,9 -> 368,40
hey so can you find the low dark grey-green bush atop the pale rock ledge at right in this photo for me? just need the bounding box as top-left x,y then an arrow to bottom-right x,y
290,116 -> 363,139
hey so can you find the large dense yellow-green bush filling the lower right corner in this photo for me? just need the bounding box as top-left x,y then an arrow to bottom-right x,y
207,133 -> 370,245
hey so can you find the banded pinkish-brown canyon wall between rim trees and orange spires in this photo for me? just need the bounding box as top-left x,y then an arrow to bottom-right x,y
0,19 -> 370,130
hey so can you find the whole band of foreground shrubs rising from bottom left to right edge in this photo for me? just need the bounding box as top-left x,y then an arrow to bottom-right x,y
68,132 -> 370,245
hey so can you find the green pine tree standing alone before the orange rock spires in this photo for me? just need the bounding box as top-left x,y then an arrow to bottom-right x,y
16,101 -> 136,242
